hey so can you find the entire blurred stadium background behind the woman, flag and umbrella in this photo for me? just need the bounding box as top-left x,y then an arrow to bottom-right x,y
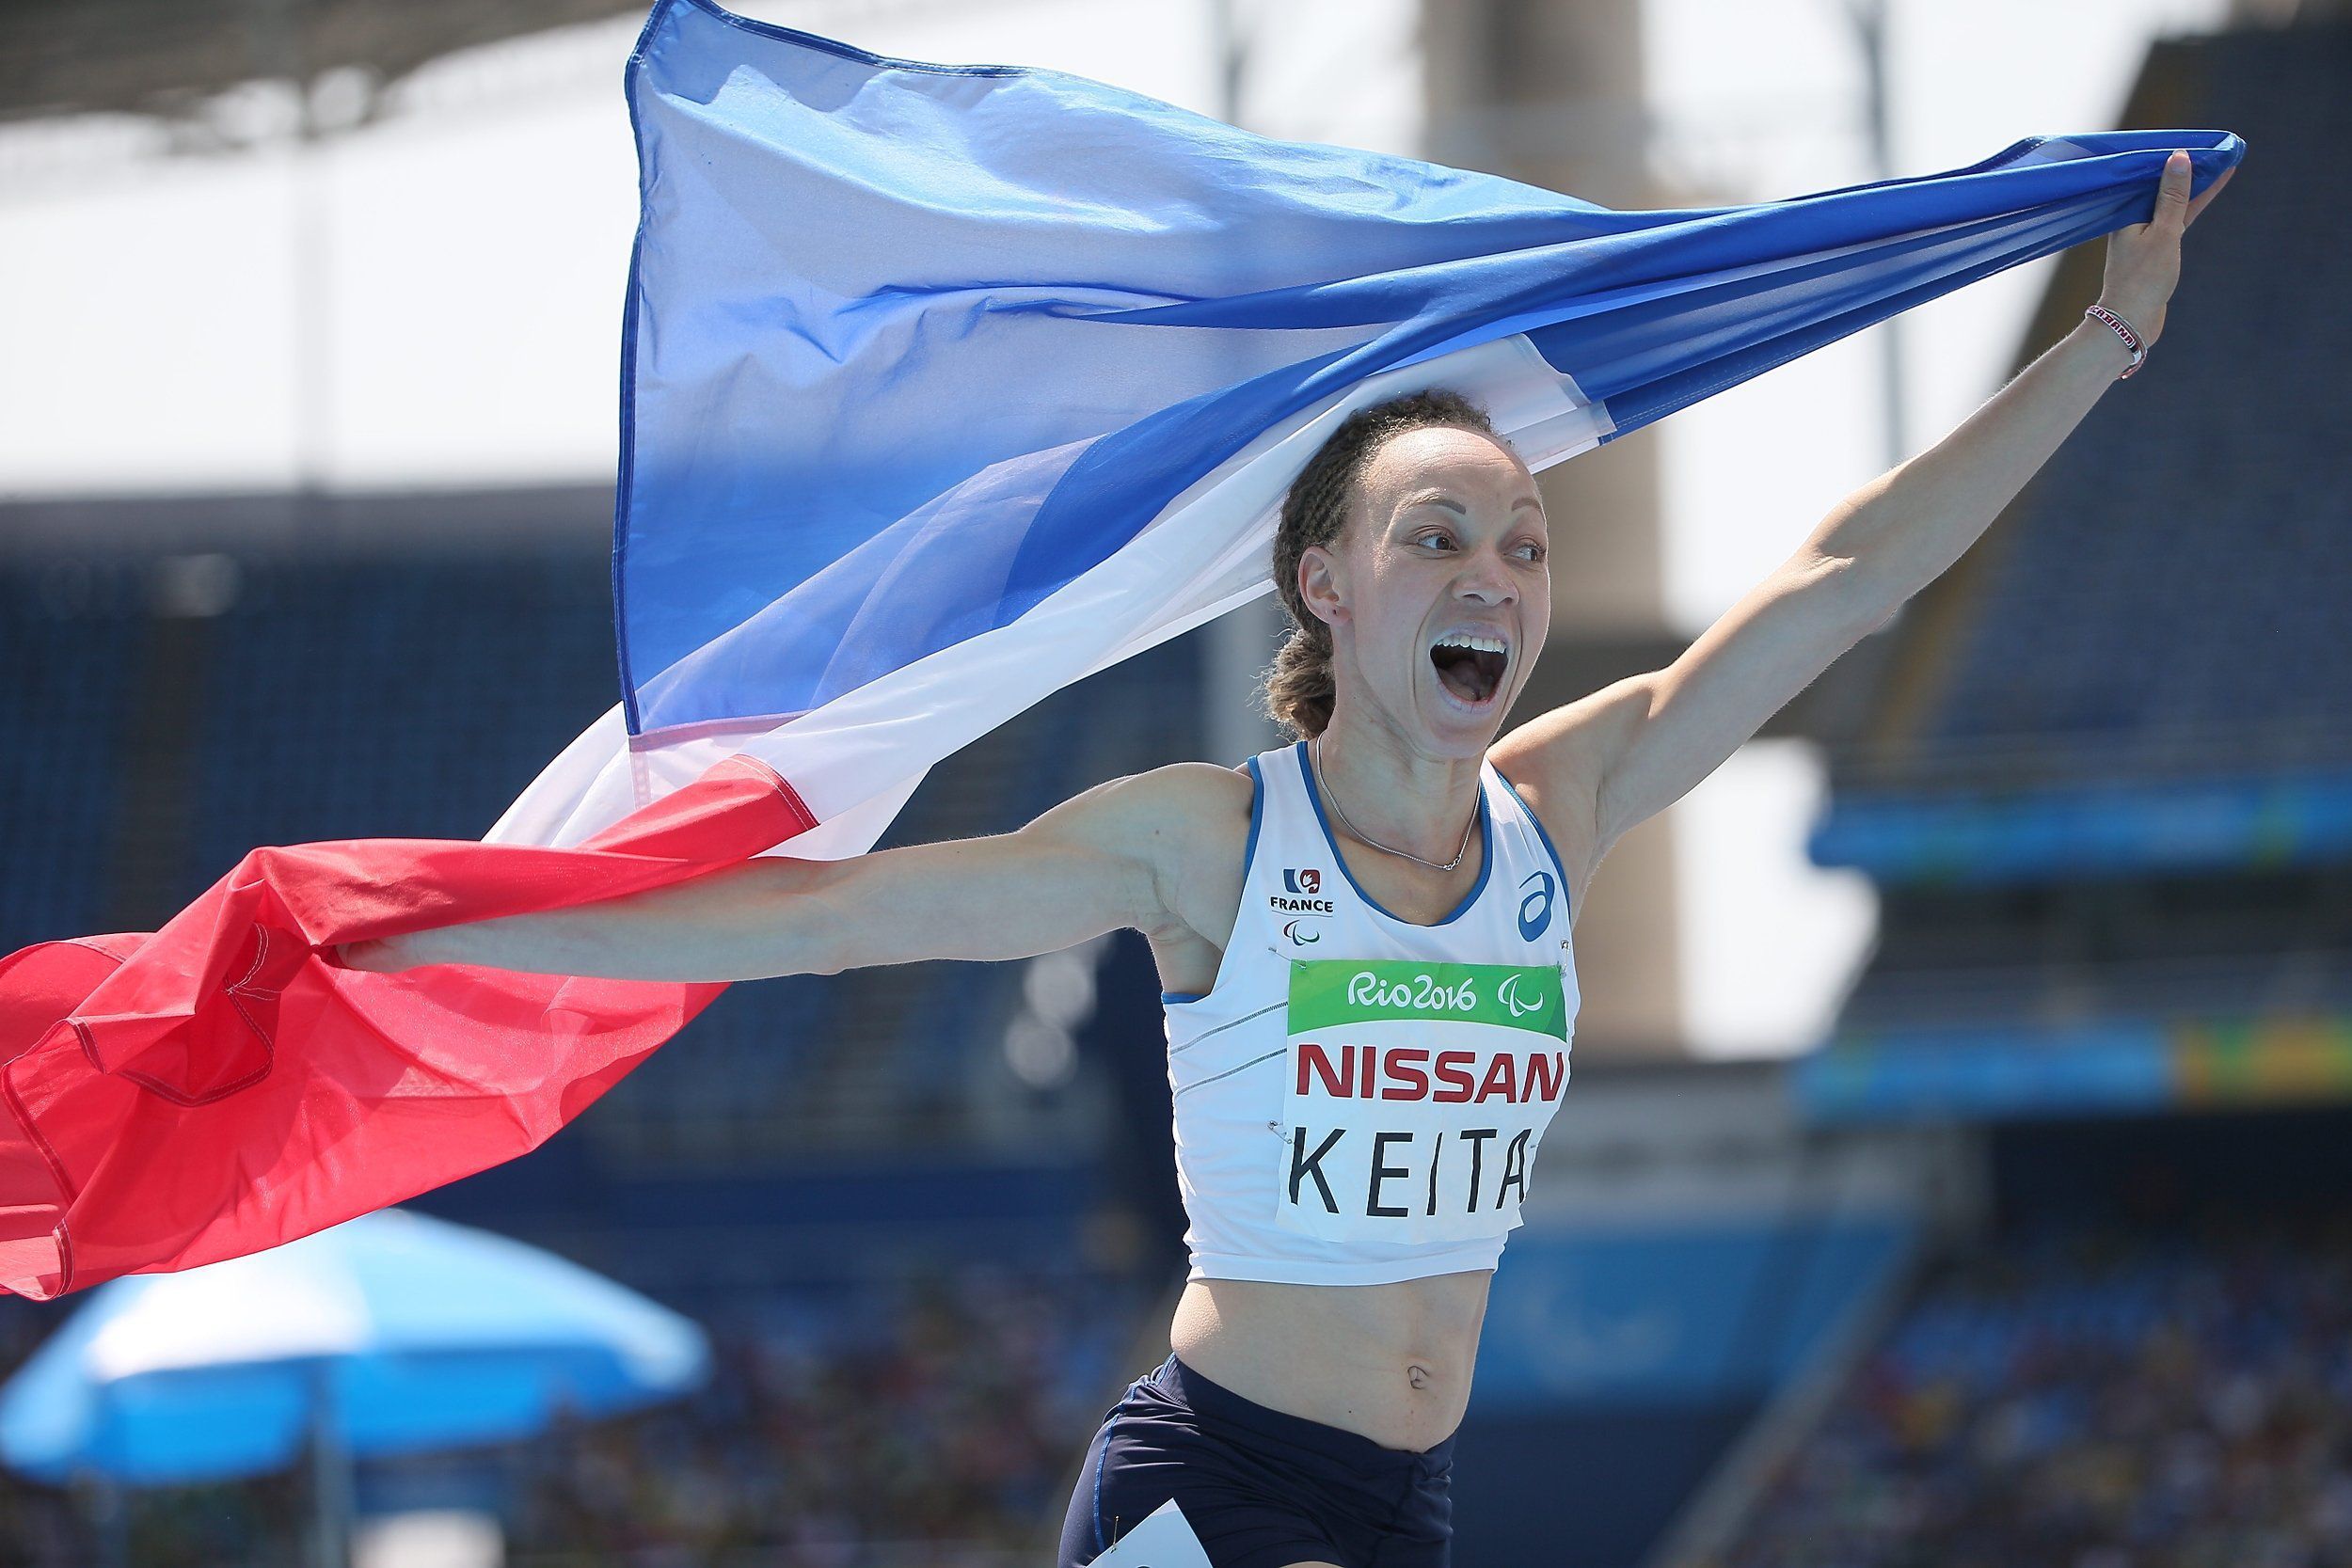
0,0 -> 2352,1568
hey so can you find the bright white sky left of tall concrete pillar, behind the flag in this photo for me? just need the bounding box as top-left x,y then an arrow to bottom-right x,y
0,0 -> 1421,496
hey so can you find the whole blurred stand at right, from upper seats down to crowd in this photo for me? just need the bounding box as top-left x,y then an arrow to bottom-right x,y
1769,30 -> 2352,1568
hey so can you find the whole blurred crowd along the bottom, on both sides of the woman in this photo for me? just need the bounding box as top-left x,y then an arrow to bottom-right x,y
32,1194 -> 2352,1568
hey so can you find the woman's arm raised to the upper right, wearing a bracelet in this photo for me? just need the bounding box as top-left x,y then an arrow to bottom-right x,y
1496,152 -> 2234,870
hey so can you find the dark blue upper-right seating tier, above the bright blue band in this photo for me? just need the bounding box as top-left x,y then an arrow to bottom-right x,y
1849,24 -> 2352,808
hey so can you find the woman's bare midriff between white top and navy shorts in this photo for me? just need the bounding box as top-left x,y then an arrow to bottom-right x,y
1169,1270 -> 1494,1453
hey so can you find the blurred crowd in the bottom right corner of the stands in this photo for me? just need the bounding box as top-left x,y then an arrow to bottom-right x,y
1722,1211 -> 2352,1568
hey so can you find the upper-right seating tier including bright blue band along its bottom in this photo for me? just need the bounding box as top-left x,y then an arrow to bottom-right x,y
1814,21 -> 2352,884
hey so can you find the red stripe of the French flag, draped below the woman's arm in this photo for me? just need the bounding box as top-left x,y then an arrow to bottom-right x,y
0,754 -> 817,1300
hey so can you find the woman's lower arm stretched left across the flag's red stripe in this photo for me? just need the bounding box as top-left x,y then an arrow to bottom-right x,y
342,764 -> 1209,980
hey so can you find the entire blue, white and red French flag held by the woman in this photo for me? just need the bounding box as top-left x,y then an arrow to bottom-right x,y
0,0 -> 2244,1300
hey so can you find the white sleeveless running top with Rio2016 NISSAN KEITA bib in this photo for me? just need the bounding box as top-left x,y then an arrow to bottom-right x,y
1162,740 -> 1579,1286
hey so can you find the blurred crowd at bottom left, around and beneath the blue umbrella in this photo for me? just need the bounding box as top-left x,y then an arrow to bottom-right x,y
0,1265 -> 1151,1568
